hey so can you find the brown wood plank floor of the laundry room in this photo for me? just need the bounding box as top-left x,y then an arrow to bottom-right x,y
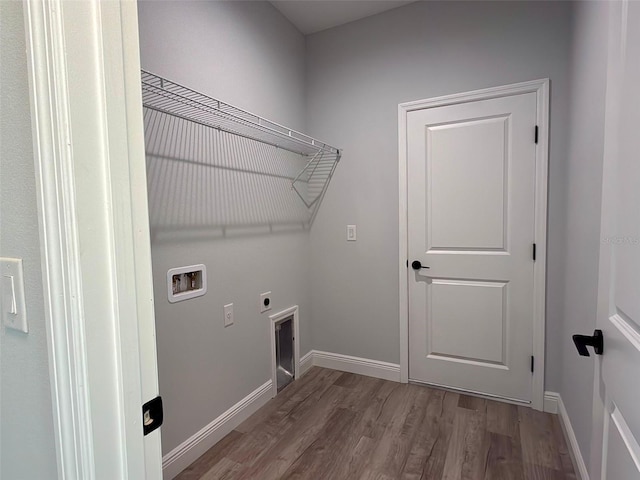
177,367 -> 576,480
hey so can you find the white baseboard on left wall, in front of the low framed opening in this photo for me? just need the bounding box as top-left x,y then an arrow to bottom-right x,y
162,380 -> 272,480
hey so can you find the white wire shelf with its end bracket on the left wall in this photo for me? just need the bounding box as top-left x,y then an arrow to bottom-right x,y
141,70 -> 342,221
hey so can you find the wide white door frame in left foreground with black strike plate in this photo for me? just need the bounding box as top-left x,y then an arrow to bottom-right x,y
24,0 -> 162,479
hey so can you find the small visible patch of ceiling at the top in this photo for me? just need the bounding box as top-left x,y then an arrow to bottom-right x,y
271,0 -> 414,35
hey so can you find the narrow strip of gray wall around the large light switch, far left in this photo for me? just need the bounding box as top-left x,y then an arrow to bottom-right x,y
0,1 -> 57,480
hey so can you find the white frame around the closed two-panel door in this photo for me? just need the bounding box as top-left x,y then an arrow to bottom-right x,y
398,79 -> 549,410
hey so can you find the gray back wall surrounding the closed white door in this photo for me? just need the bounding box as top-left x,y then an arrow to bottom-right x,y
307,2 -> 572,390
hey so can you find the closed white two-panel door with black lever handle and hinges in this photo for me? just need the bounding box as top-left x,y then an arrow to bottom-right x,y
407,92 -> 537,402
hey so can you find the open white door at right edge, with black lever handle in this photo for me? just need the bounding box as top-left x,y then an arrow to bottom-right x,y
592,2 -> 640,480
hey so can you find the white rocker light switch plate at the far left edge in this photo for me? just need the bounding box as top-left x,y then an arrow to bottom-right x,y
0,257 -> 29,333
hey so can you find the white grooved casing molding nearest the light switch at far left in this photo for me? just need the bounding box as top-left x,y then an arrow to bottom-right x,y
24,0 -> 95,479
